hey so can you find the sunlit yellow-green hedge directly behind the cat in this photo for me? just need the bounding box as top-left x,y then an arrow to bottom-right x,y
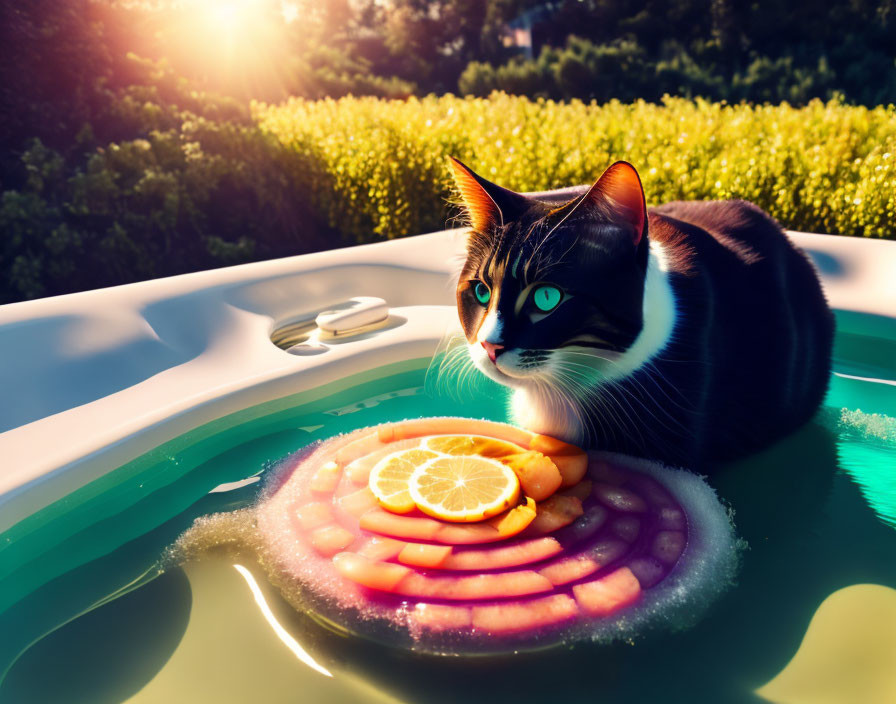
254,93 -> 896,241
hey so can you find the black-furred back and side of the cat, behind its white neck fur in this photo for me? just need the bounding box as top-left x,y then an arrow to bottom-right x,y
632,201 -> 834,466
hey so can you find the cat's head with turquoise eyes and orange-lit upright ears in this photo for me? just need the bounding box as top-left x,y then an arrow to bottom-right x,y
451,159 -> 648,395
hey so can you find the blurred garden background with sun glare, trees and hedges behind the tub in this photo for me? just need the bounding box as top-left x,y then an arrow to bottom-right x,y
0,0 -> 896,303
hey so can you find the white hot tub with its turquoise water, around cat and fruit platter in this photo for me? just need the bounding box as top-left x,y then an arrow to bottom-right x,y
0,231 -> 896,702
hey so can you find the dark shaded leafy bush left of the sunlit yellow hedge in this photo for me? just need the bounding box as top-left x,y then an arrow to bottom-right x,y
0,110 -> 339,303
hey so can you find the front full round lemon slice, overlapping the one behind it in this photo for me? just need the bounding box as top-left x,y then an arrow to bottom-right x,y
409,455 -> 520,523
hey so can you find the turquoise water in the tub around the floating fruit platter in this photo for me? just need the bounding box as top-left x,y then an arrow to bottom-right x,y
0,336 -> 896,703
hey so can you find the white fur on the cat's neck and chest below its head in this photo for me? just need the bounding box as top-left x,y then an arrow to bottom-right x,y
510,242 -> 676,443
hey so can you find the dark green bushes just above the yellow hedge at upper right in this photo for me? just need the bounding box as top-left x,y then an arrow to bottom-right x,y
458,36 -> 896,105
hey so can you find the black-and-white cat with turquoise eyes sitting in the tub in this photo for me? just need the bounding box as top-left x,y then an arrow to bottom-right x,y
451,159 -> 834,470
